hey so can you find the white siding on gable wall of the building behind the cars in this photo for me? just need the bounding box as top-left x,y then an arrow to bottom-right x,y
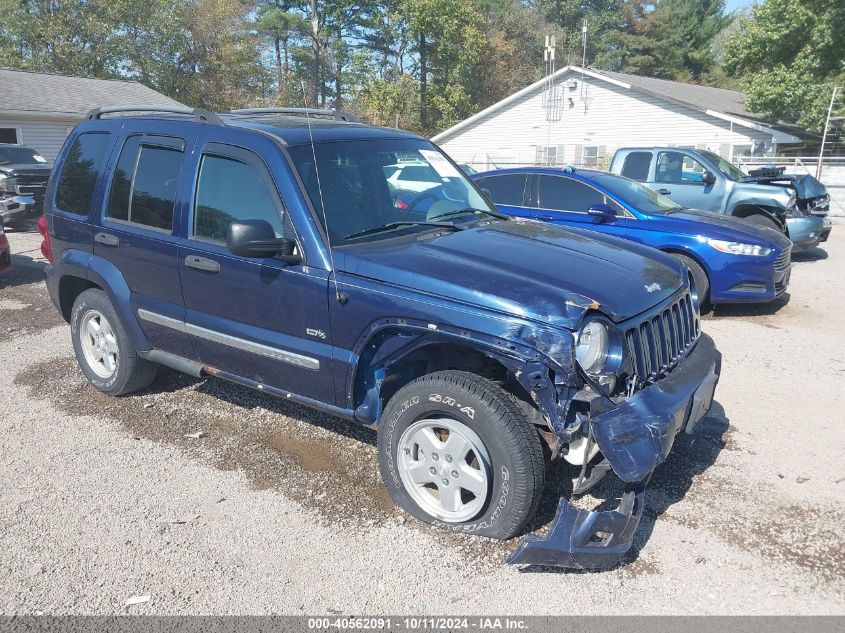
437,75 -> 772,169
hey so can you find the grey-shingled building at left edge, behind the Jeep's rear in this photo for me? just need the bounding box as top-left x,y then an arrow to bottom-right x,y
0,68 -> 182,161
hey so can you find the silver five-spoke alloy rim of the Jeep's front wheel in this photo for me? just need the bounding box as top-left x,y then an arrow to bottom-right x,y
397,417 -> 491,523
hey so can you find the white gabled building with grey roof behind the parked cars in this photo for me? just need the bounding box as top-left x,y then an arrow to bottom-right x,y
432,66 -> 806,170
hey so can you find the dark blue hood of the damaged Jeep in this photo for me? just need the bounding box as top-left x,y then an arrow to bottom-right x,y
337,220 -> 685,329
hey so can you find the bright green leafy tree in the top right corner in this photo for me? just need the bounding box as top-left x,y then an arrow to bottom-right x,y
724,0 -> 845,131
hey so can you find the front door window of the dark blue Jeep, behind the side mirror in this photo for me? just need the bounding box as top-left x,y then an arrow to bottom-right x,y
193,154 -> 284,242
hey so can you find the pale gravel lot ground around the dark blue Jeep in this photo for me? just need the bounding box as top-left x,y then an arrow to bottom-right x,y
0,230 -> 845,615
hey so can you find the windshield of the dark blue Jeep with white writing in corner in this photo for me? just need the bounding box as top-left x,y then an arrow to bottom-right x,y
288,139 -> 495,246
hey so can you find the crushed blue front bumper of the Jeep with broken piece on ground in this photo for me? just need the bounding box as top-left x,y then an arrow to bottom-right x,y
508,334 -> 722,569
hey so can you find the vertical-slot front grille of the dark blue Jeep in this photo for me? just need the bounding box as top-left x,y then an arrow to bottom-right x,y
625,292 -> 701,381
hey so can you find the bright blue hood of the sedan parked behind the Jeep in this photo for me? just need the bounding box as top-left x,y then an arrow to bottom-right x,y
648,209 -> 790,249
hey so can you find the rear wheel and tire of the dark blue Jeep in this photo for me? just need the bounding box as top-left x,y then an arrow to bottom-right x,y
70,288 -> 158,396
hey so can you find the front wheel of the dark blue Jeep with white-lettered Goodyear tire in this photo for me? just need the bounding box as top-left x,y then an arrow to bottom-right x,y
378,371 -> 545,539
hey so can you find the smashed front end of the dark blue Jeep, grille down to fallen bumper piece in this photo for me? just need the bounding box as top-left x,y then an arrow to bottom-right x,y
508,295 -> 721,569
